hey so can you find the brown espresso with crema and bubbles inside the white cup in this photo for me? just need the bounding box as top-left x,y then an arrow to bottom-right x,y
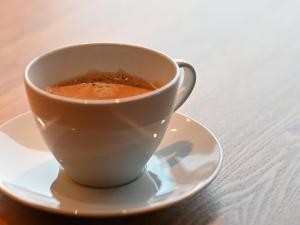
46,71 -> 159,100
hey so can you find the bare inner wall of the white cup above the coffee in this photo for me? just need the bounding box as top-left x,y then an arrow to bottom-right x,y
28,44 -> 176,89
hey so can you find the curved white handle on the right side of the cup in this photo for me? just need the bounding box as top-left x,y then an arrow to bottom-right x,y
174,59 -> 196,111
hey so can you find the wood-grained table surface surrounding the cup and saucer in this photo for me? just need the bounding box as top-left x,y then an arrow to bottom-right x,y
0,0 -> 300,225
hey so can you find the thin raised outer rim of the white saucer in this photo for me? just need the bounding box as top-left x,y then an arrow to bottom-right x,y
0,111 -> 224,218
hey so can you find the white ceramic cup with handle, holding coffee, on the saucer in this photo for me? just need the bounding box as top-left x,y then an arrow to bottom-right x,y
24,43 -> 196,187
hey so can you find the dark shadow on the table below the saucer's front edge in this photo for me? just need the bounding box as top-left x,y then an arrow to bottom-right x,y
0,187 -> 221,225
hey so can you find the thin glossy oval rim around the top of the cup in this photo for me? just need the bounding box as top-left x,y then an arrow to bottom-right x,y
24,42 -> 179,105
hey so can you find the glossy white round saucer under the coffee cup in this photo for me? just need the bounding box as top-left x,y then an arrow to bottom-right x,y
0,112 -> 223,217
